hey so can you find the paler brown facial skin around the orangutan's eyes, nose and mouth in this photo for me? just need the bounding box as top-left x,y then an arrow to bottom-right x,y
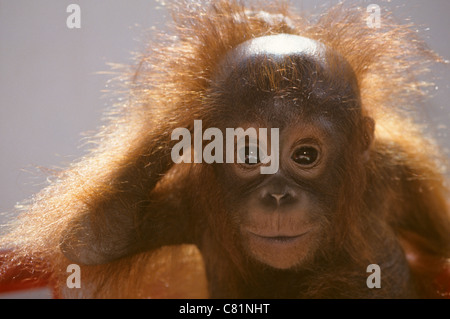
217,123 -> 339,269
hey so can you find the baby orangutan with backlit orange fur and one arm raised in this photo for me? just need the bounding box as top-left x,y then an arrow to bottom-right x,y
0,1 -> 450,298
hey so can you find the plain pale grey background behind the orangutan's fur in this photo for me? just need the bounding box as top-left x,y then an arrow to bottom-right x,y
0,0 -> 450,296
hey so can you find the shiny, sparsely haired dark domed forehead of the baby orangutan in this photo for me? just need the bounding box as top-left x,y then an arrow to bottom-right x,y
213,34 -> 359,121
